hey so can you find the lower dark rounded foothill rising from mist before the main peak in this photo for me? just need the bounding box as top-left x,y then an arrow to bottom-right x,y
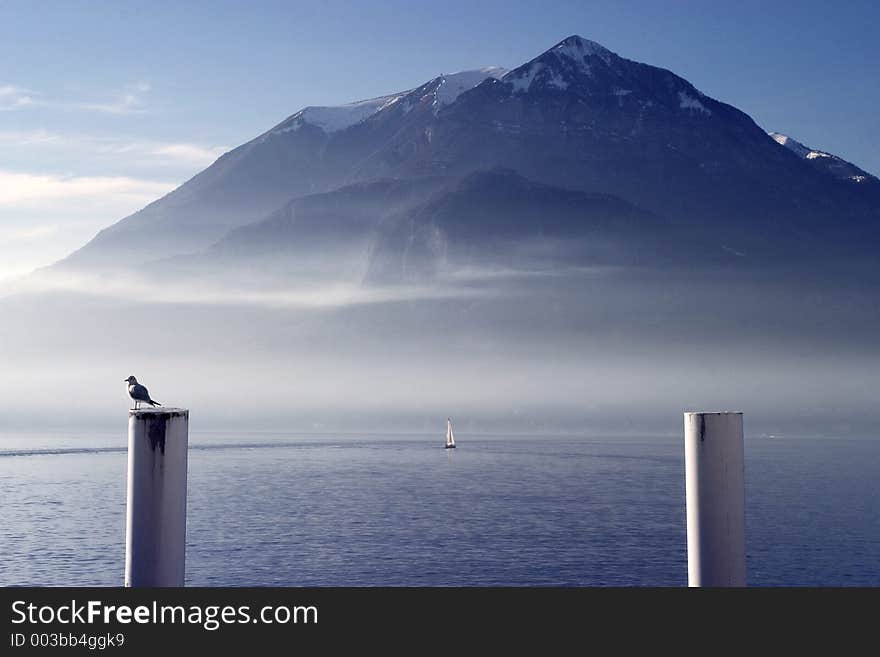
367,169 -> 696,282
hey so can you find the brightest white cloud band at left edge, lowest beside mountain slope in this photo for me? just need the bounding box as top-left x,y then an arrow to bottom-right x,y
0,169 -> 174,208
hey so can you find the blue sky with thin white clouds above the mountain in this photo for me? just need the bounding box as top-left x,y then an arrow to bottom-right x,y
0,0 -> 880,279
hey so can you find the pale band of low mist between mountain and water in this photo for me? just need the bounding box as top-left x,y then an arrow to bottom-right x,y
0,258 -> 880,434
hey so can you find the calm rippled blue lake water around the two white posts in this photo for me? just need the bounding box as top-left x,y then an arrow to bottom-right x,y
0,434 -> 880,586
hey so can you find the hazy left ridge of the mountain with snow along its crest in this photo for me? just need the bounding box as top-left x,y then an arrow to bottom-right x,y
59,67 -> 506,270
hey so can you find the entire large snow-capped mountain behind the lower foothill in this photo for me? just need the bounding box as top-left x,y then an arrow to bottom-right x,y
53,36 -> 880,270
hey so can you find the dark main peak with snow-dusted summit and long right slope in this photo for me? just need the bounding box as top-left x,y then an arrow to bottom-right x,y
431,37 -> 880,255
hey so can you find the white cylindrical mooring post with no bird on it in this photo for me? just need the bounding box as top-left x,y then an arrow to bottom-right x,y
684,413 -> 746,586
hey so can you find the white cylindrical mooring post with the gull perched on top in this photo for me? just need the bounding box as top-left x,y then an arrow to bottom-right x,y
125,407 -> 189,587
